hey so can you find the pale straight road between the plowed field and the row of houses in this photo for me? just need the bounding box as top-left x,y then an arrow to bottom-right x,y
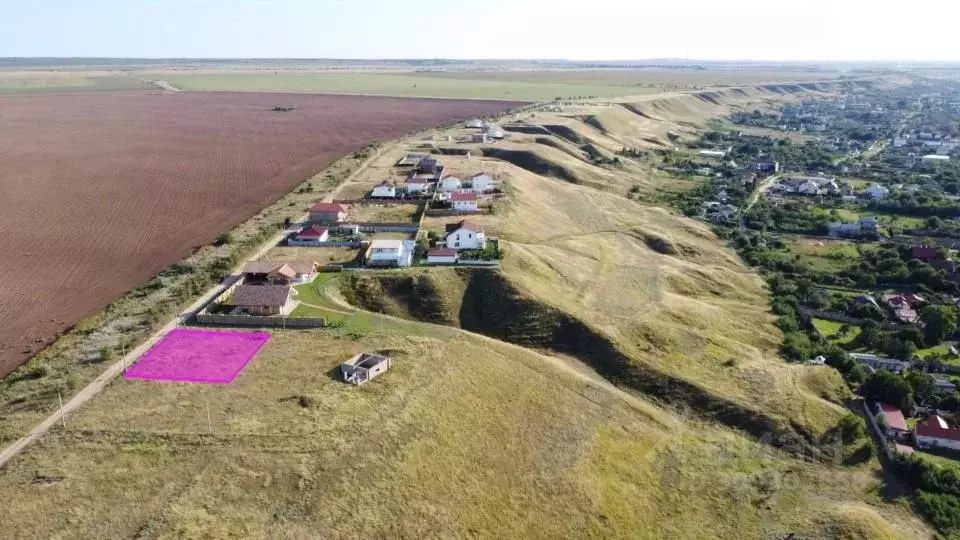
0,143 -> 383,467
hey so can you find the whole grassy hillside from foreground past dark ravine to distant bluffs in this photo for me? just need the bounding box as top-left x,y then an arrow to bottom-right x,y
0,79 -> 930,539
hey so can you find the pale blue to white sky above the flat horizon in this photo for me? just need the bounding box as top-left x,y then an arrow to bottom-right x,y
0,0 -> 960,61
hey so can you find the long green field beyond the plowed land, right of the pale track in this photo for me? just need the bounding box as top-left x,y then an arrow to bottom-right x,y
167,72 -> 658,101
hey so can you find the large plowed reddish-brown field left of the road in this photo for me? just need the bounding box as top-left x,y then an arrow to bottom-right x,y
0,92 -> 516,377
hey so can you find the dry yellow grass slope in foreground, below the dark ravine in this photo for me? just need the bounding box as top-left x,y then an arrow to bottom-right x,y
0,327 -> 924,538
